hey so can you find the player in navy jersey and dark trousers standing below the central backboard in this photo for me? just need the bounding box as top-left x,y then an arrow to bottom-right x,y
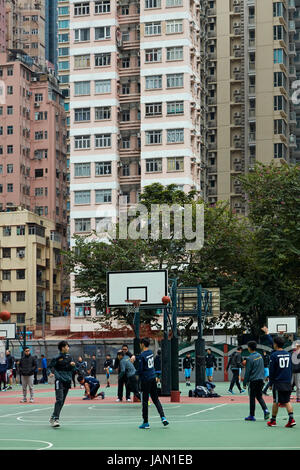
137,338 -> 169,429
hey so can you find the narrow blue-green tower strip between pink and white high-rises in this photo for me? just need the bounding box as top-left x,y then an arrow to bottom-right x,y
45,0 -> 58,72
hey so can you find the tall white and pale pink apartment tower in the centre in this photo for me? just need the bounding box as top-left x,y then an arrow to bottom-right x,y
69,0 -> 203,331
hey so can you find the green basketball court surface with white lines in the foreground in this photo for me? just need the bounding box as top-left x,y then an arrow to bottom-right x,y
0,383 -> 300,451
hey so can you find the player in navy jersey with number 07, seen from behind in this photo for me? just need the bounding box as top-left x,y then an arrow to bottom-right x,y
267,336 -> 296,428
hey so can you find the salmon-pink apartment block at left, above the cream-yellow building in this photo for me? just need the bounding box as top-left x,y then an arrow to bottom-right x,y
0,52 -> 67,246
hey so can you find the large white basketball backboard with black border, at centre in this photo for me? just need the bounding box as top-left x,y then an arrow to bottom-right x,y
107,269 -> 168,308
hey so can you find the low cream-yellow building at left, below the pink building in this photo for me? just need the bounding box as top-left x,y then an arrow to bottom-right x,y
0,208 -> 62,330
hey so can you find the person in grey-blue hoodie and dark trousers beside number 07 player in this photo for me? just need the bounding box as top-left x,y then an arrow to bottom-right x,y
243,341 -> 270,421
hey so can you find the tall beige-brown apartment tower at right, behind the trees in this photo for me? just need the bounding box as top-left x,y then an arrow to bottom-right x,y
200,0 -> 300,213
